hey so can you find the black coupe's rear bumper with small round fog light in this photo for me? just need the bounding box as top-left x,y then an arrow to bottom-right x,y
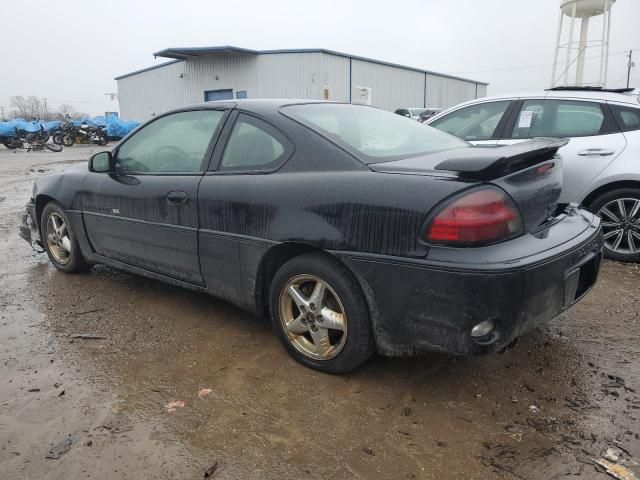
343,205 -> 603,355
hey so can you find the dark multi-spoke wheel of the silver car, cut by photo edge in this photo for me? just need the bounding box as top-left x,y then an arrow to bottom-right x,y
589,188 -> 640,263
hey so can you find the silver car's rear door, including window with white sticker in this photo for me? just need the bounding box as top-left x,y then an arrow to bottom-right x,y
498,98 -> 627,203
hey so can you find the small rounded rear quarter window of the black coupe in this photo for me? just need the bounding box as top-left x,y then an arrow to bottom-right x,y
220,114 -> 287,170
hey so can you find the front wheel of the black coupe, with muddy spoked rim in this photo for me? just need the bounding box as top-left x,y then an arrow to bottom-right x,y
40,202 -> 89,273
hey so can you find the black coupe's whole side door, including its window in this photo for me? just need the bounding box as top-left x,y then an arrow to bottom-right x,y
82,109 -> 226,284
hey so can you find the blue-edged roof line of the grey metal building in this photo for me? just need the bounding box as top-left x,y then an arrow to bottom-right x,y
115,45 -> 488,85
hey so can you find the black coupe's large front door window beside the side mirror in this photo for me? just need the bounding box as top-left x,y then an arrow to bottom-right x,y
116,110 -> 224,173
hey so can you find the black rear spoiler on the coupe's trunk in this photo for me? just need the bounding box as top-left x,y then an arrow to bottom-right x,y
435,138 -> 569,180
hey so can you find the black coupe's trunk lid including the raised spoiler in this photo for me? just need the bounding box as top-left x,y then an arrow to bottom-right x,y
369,138 -> 568,233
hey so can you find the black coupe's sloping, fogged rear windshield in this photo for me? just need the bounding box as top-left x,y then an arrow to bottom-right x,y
282,103 -> 469,163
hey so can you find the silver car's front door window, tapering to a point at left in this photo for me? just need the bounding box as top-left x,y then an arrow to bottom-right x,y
429,100 -> 511,141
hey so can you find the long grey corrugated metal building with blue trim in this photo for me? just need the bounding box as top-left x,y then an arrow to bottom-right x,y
116,46 -> 487,120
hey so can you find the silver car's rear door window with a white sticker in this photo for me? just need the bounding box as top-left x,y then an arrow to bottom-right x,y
513,100 -> 609,138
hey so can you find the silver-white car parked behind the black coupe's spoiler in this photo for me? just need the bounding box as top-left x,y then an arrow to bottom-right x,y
426,88 -> 640,262
